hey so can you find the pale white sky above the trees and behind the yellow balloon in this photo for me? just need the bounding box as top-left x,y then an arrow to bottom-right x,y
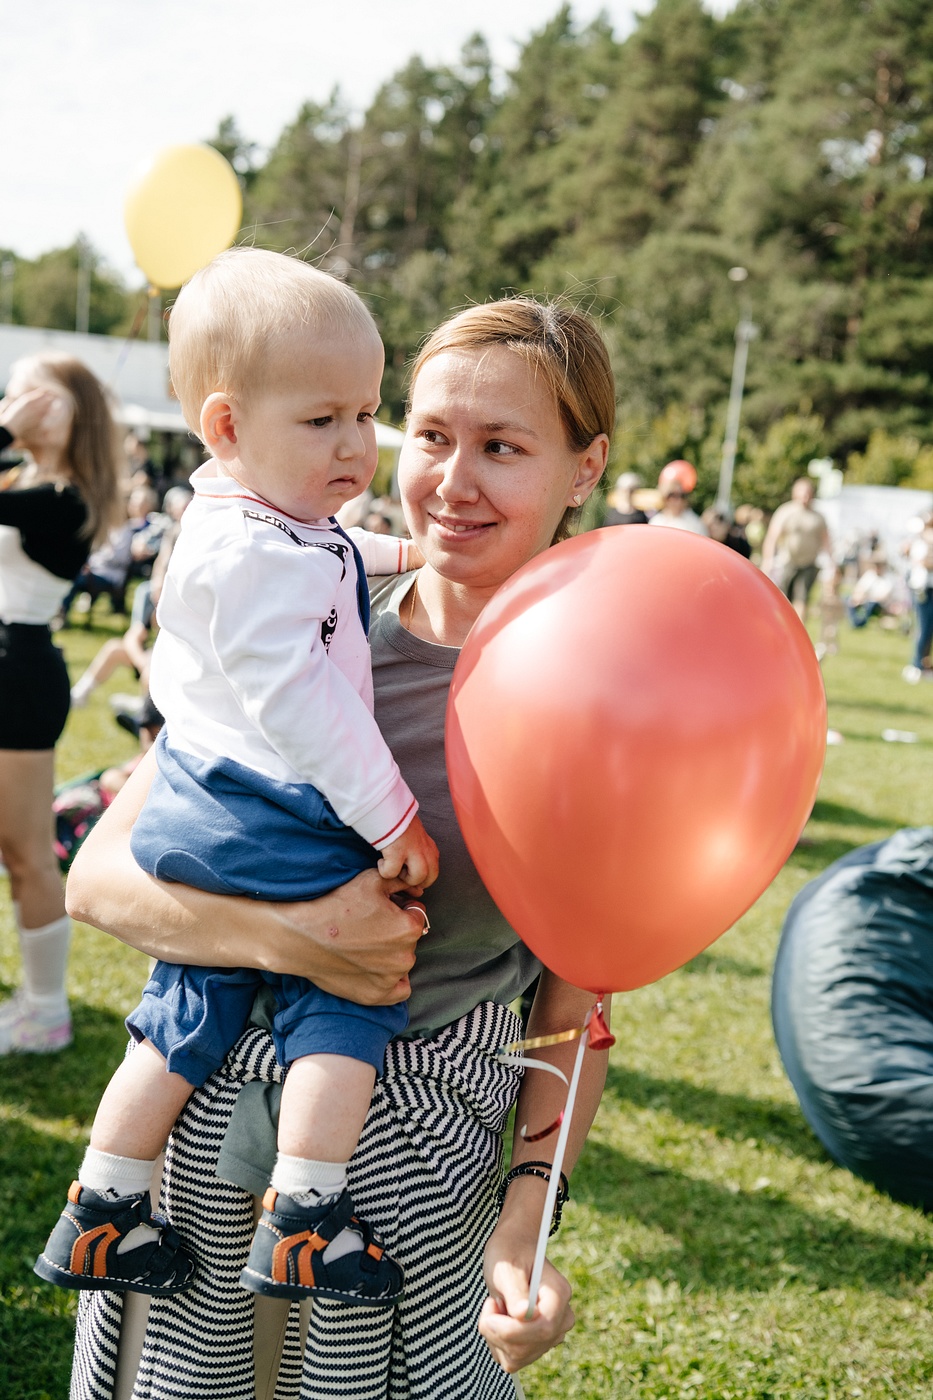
0,0 -> 730,283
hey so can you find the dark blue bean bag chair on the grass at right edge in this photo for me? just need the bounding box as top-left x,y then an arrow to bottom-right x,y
772,826 -> 933,1211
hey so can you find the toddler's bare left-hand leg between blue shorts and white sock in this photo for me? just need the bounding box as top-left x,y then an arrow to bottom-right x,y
91,1040 -> 192,1161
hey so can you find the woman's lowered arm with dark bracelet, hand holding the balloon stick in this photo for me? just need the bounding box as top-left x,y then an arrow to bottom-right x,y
479,970 -> 608,1372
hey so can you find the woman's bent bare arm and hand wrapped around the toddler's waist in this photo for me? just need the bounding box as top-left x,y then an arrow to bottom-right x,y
66,750 -> 423,1005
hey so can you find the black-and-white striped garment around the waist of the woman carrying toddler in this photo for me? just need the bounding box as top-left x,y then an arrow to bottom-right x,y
71,1002 -> 520,1400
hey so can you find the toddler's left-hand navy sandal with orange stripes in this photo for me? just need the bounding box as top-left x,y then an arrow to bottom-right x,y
35,1182 -> 195,1296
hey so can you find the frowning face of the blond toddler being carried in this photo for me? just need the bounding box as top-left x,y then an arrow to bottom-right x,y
224,324 -> 384,521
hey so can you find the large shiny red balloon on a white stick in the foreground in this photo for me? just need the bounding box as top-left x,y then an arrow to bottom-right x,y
447,525 -> 827,993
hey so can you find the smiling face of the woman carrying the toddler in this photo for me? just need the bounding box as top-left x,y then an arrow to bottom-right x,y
399,346 -> 599,588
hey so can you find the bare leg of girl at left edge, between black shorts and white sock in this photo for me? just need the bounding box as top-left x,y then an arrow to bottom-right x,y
0,749 -> 64,928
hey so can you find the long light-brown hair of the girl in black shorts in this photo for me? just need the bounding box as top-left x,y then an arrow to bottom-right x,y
10,351 -> 123,543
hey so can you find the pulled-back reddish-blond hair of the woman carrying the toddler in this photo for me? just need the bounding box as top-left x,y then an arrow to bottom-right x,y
409,297 -> 615,542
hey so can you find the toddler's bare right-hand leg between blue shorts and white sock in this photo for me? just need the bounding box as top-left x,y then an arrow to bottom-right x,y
275,1054 -> 375,1162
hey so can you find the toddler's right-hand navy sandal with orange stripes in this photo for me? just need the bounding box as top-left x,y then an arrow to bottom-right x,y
240,1187 -> 403,1306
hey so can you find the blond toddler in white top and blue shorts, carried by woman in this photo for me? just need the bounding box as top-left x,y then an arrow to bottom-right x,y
36,249 -> 437,1303
